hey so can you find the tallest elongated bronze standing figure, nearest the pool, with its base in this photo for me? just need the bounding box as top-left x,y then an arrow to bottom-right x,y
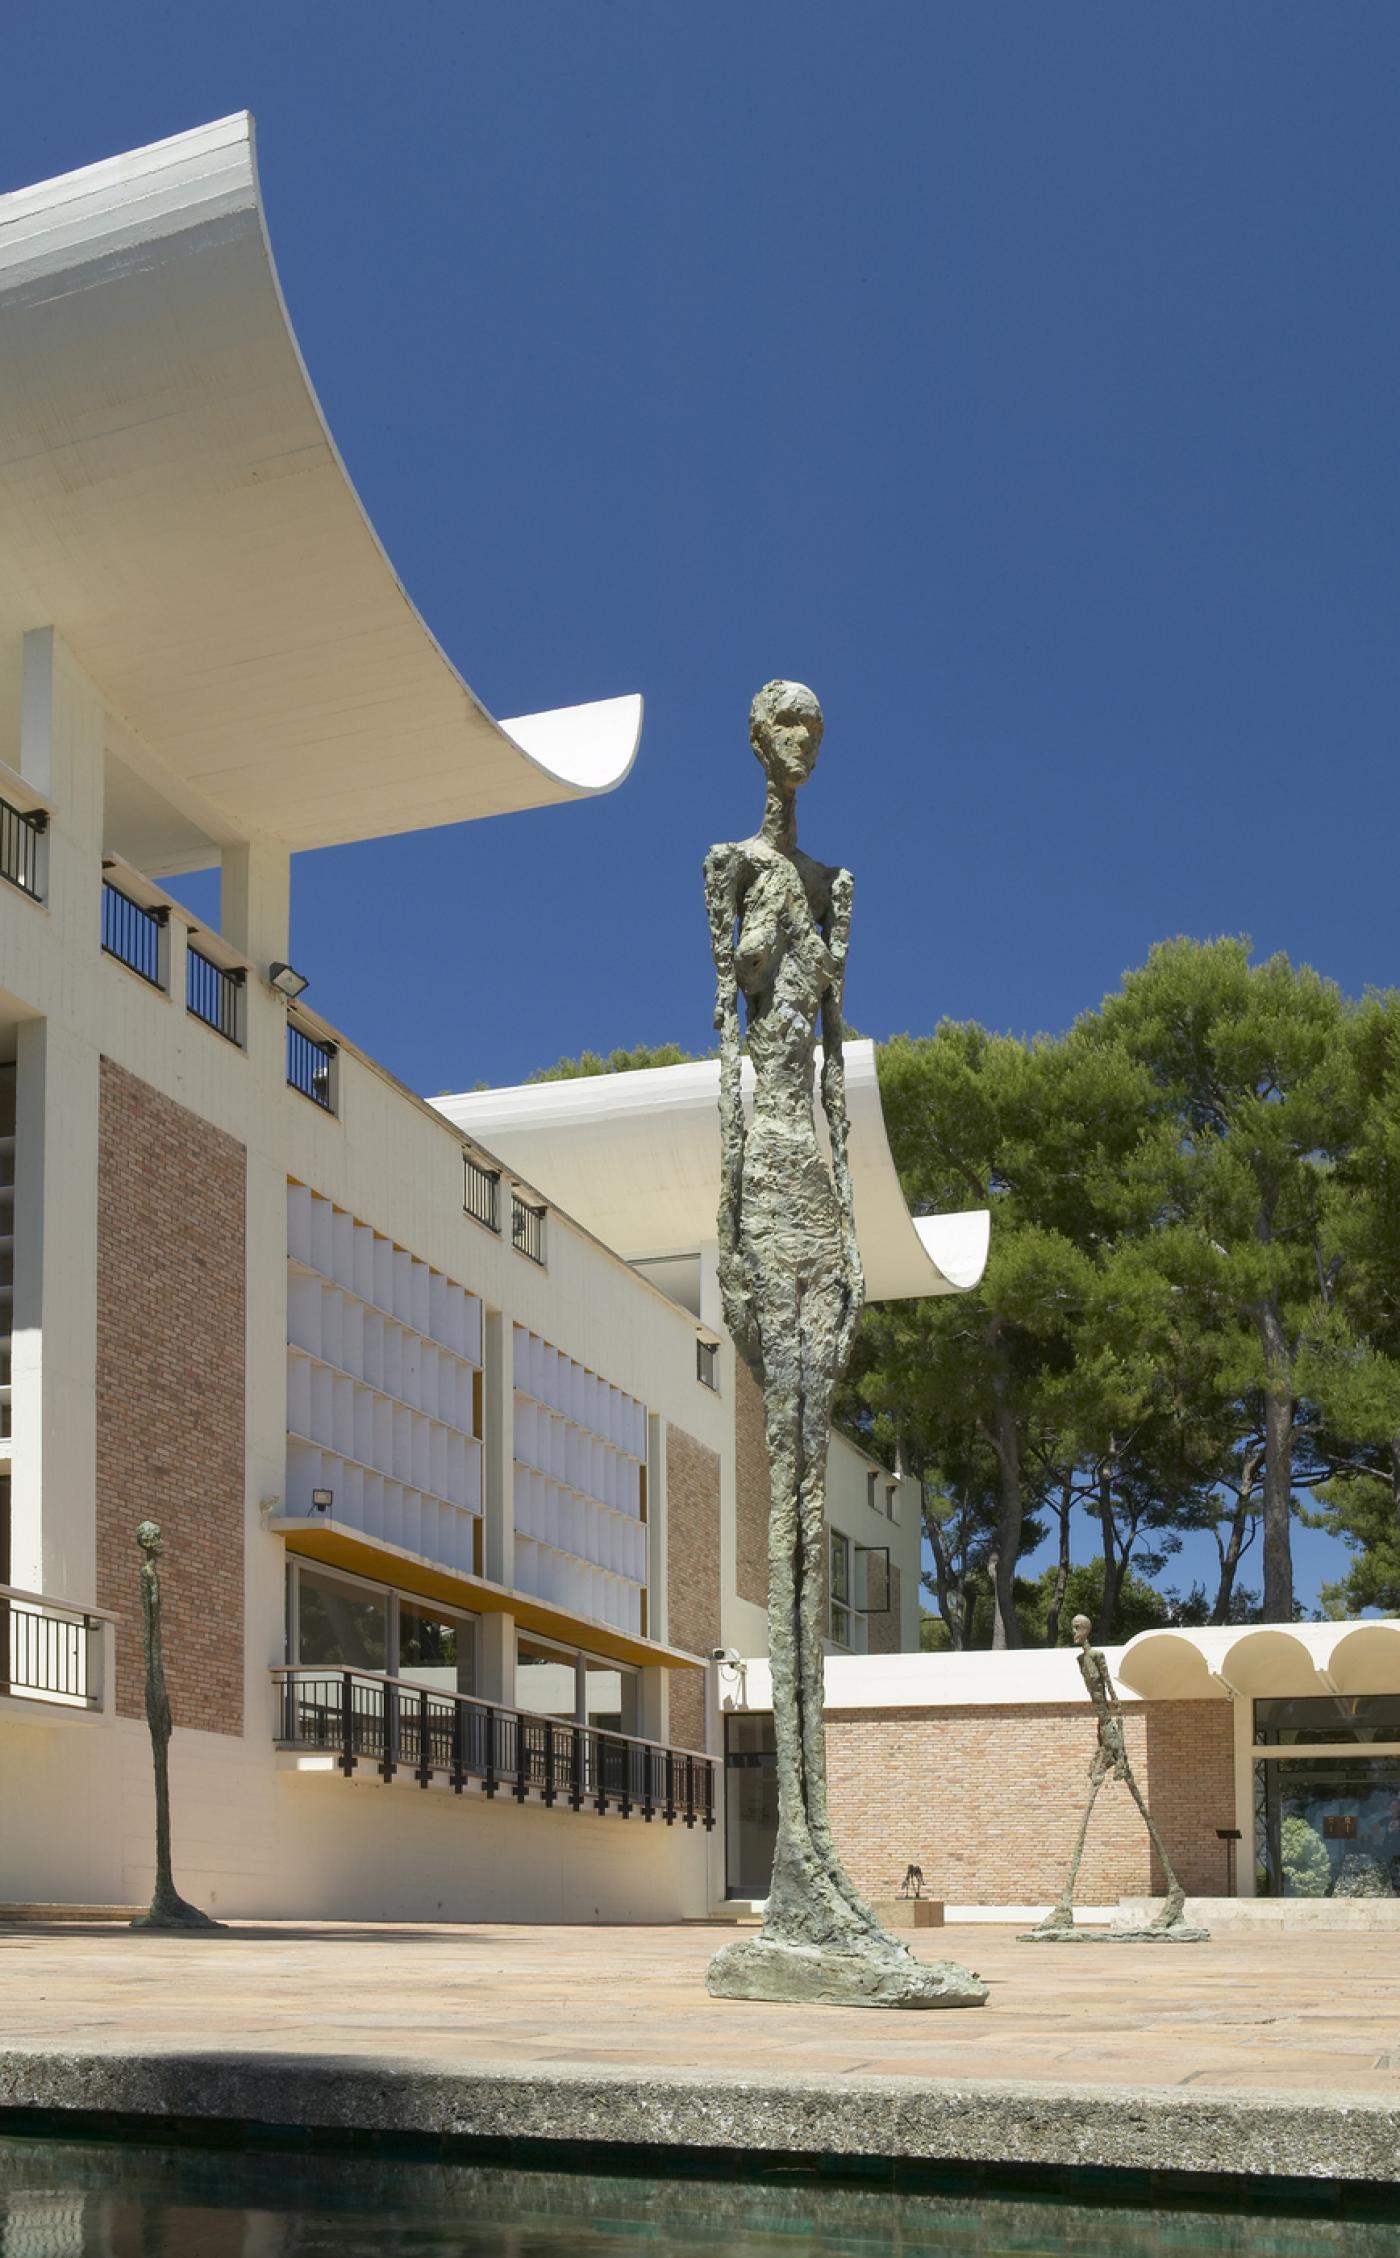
705,682 -> 987,2007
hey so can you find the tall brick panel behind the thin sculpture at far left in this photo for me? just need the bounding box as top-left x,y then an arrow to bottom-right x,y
97,1059 -> 246,1734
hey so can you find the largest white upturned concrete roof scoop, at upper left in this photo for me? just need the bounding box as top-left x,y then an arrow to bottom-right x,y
0,113 -> 641,867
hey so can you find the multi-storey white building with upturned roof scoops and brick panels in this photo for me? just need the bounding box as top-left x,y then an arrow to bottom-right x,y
0,117 -> 985,1919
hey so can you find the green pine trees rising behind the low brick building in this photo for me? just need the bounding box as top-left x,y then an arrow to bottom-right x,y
523,939 -> 1400,1648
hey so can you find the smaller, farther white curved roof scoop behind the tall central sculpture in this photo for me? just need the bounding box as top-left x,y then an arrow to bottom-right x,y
434,1041 -> 989,1301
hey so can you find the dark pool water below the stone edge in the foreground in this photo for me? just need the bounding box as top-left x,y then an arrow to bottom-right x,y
0,2138 -> 1400,2258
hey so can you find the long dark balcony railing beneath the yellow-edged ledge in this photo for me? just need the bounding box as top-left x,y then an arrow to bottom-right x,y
273,1666 -> 716,1829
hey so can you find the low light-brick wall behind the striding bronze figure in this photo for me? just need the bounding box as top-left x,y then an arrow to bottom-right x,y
826,1700 -> 1235,1906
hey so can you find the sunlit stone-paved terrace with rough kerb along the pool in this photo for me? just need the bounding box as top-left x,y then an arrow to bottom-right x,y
0,1924 -> 1400,2181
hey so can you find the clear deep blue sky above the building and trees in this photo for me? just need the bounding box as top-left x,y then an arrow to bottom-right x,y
0,0 -> 1400,1616
